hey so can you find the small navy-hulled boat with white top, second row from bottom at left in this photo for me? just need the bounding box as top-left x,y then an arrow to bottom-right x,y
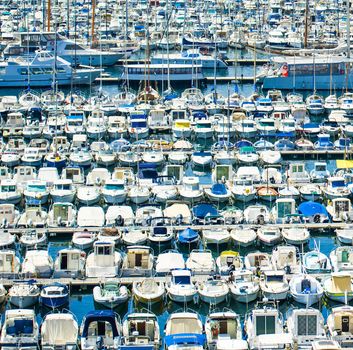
40,282 -> 69,309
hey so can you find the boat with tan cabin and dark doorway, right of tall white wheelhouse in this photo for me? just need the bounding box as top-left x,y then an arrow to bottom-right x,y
122,246 -> 154,276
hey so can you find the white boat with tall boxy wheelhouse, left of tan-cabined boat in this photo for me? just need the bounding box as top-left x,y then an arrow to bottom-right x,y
86,241 -> 122,277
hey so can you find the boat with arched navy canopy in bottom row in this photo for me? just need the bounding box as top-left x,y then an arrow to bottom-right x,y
80,310 -> 121,350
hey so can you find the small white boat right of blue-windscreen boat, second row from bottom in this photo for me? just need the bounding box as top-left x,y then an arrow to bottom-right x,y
198,278 -> 229,305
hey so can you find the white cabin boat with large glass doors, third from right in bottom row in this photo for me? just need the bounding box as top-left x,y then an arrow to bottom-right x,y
244,302 -> 293,349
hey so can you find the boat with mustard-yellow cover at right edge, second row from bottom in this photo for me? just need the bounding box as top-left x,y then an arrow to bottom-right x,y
322,271 -> 353,305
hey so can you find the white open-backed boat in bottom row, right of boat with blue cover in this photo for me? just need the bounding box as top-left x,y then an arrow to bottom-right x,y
205,310 -> 243,350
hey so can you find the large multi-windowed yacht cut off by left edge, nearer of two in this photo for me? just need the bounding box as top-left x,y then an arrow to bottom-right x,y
0,51 -> 101,87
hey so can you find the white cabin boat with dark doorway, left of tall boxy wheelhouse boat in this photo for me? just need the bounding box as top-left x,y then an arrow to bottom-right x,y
53,248 -> 86,278
